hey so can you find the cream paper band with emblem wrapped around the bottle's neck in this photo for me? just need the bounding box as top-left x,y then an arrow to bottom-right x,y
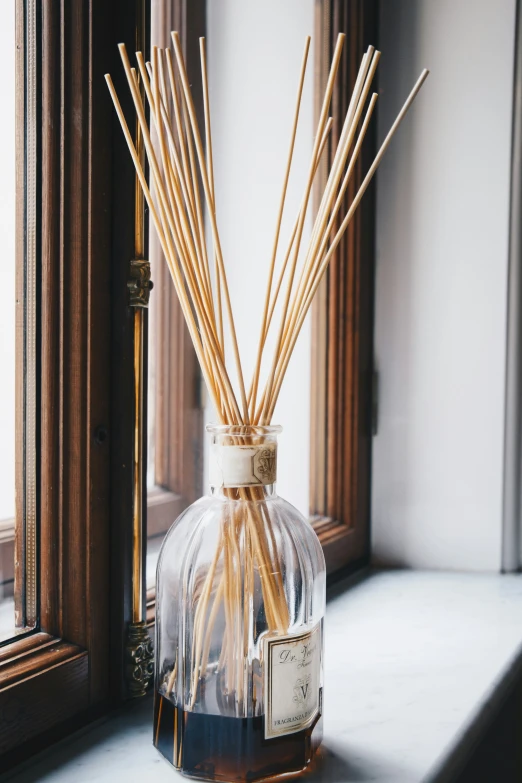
210,443 -> 277,487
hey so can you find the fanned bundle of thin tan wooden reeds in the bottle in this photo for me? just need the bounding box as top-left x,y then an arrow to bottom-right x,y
105,32 -> 428,699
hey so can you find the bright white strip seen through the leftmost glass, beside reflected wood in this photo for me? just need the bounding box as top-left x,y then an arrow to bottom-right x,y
0,2 -> 16,524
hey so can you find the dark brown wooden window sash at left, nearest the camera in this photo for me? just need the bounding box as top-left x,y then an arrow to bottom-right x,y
0,0 -> 132,771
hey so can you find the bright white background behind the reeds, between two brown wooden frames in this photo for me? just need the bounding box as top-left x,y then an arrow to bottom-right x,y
207,0 -> 314,514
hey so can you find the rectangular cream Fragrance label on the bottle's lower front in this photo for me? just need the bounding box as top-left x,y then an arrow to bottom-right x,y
264,624 -> 322,739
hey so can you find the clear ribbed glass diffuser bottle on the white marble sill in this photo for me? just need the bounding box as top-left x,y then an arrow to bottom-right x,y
154,426 -> 326,781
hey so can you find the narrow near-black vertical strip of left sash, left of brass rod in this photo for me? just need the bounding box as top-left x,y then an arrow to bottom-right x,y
87,0 -> 114,704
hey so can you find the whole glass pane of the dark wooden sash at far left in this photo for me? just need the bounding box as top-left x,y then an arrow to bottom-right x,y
0,0 -> 37,642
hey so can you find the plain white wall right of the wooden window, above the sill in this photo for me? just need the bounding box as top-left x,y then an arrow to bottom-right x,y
372,0 -> 515,570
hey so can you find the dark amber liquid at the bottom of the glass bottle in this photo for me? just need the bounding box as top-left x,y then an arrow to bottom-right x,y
154,692 -> 322,783
